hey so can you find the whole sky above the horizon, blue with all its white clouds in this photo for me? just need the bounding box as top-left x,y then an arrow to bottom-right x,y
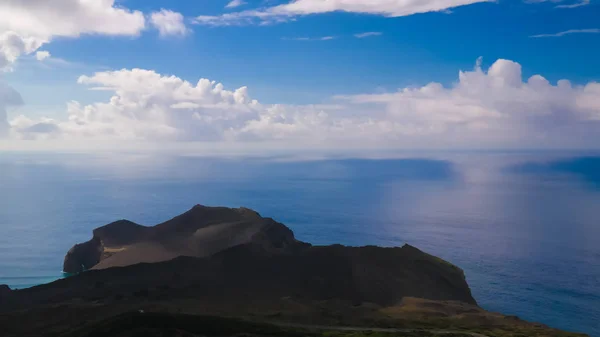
0,0 -> 600,152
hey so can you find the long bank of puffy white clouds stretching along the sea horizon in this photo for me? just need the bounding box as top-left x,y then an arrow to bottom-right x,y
11,60 -> 600,148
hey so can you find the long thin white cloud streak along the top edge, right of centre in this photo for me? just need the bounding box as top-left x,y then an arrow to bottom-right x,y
195,0 -> 494,26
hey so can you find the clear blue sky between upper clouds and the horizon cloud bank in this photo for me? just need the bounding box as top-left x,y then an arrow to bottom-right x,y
0,0 -> 600,147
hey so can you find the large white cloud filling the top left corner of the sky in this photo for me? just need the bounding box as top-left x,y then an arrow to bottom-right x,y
0,0 -> 145,70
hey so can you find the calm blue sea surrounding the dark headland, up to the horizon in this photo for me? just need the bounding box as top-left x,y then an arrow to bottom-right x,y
0,153 -> 600,337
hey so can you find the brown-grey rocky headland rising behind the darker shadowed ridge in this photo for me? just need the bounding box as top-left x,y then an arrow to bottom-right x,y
63,205 -> 307,273
